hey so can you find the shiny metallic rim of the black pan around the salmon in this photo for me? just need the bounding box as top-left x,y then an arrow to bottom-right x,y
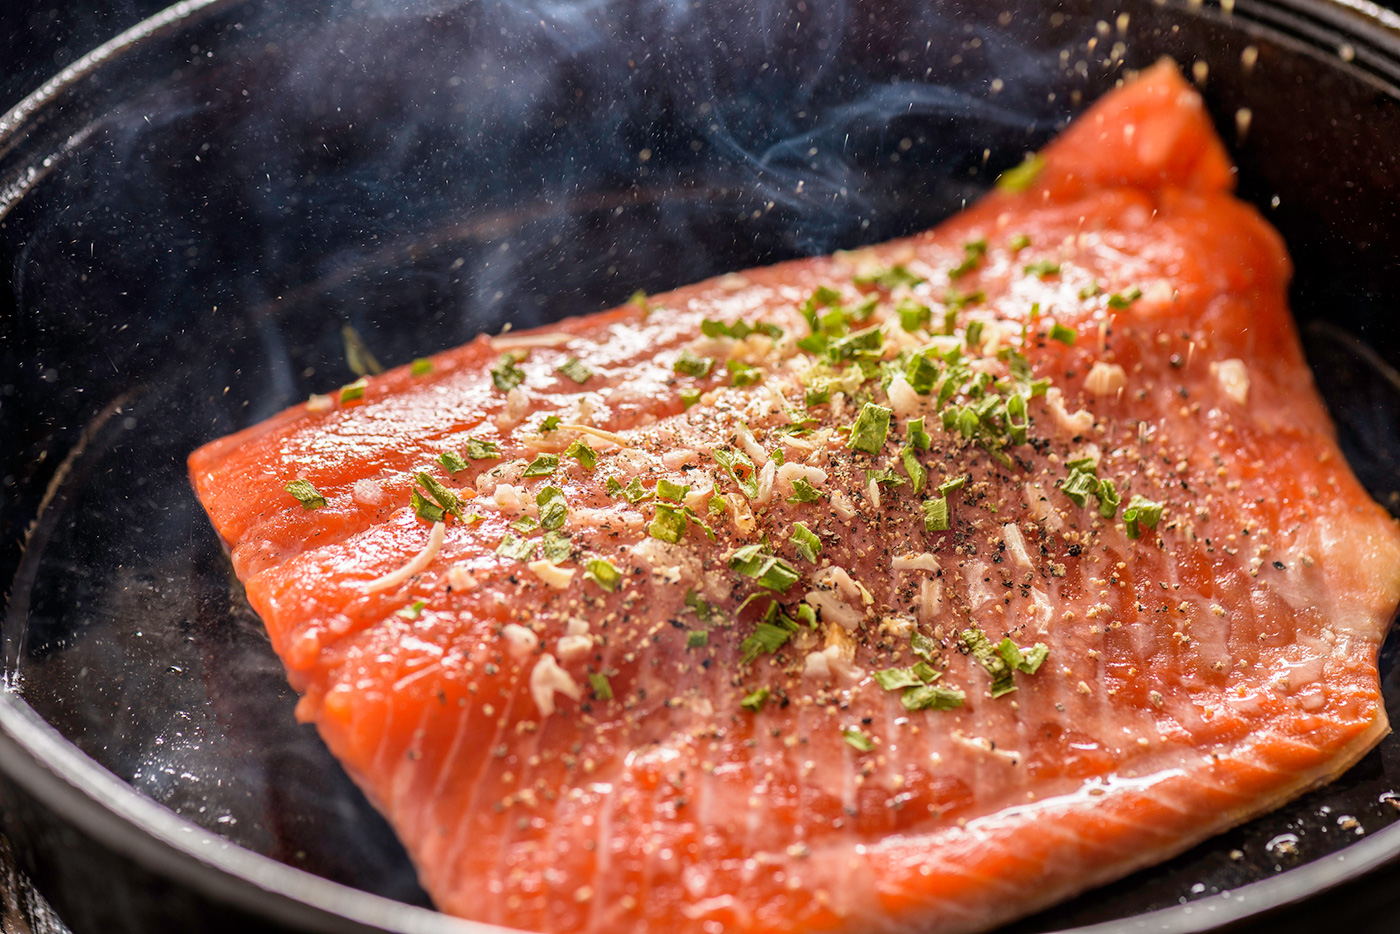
0,0 -> 1400,934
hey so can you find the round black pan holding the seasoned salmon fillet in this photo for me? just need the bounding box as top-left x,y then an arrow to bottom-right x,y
0,0 -> 1400,934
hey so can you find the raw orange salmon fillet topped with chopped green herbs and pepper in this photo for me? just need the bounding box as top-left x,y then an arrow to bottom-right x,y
189,64 -> 1400,934
